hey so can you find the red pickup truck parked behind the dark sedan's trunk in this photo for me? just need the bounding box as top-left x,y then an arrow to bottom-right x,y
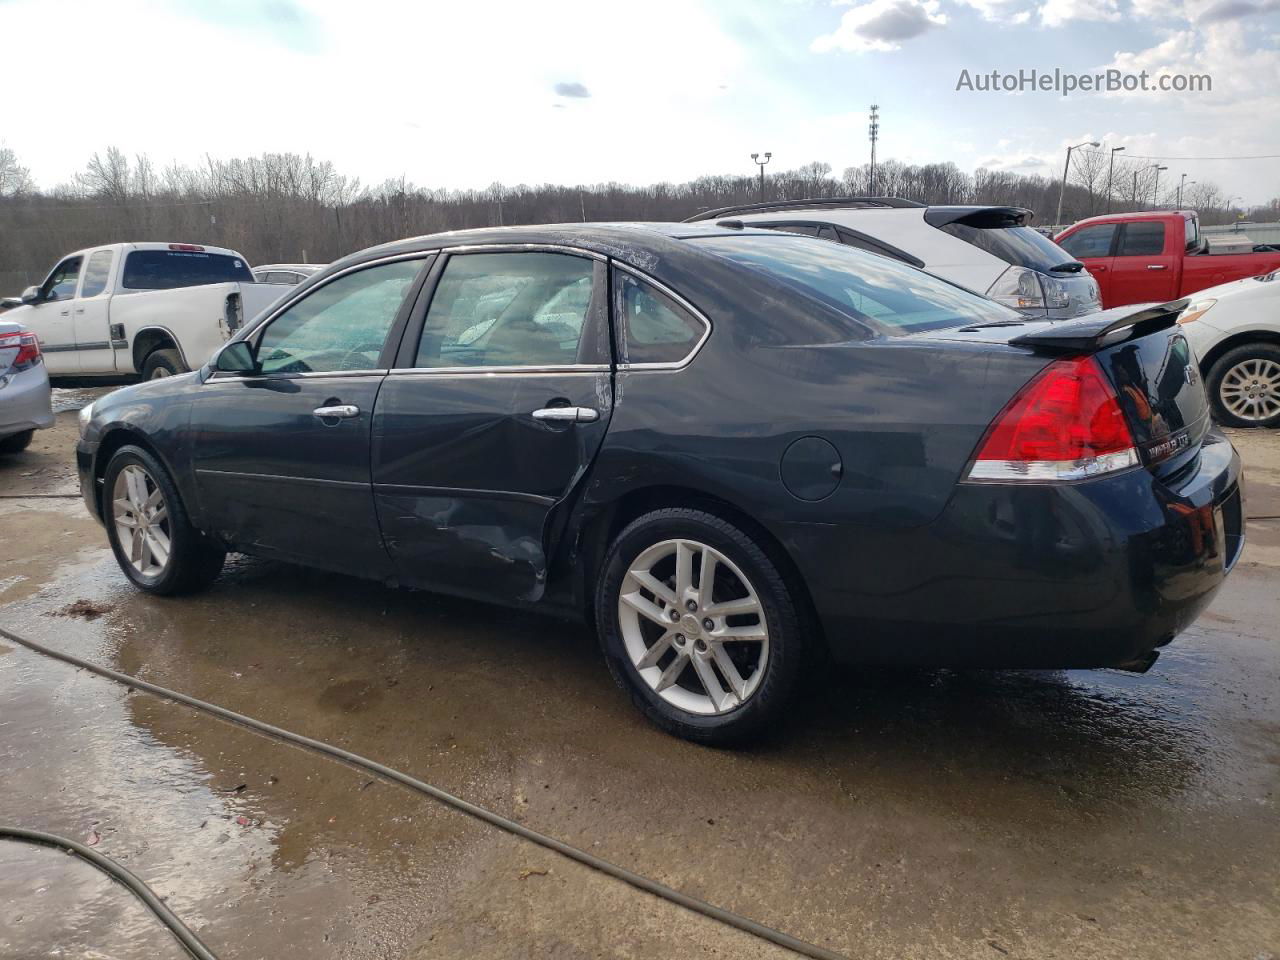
1053,210 -> 1280,307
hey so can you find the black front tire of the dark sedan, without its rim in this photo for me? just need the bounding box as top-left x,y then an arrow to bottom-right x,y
102,445 -> 227,596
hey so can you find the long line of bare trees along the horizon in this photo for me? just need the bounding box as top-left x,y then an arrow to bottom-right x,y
0,147 -> 1280,296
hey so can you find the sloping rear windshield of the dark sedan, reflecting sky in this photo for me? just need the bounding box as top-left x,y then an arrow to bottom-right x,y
694,233 -> 1019,337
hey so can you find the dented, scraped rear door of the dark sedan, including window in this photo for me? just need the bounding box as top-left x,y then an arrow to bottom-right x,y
372,248 -> 613,602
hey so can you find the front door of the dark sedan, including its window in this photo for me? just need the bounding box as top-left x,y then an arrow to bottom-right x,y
189,255 -> 429,577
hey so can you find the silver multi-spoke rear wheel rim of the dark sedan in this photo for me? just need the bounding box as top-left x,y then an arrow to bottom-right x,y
618,540 -> 769,716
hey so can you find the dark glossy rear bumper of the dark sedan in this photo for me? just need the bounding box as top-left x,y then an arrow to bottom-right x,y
785,433 -> 1244,668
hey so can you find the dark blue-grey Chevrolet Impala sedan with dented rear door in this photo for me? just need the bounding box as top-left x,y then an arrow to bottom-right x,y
78,224 -> 1243,742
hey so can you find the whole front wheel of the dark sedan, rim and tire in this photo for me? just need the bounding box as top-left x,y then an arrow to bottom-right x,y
102,447 -> 227,595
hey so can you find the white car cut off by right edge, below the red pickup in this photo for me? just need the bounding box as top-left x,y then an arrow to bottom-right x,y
1178,270 -> 1280,426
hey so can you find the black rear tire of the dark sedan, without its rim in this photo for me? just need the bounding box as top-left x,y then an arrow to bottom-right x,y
595,507 -> 809,746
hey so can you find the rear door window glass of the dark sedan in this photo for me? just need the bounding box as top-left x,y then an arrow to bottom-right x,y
413,253 -> 594,367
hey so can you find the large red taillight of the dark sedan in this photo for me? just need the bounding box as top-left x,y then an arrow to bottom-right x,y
969,357 -> 1138,480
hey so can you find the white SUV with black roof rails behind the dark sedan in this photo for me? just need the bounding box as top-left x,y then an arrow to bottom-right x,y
689,197 -> 1102,320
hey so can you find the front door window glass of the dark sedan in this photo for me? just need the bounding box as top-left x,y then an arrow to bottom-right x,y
257,260 -> 422,374
